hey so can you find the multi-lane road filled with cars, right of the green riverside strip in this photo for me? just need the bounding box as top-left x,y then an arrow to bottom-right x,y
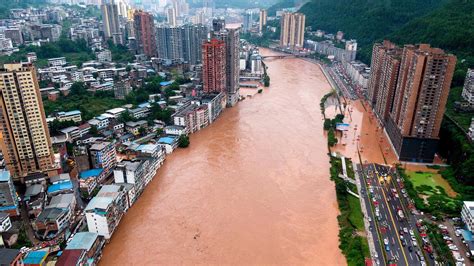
358,164 -> 433,265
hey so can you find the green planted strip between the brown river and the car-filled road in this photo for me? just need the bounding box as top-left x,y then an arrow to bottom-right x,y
330,157 -> 370,265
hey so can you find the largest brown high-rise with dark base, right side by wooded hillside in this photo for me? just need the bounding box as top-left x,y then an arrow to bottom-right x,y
372,44 -> 456,162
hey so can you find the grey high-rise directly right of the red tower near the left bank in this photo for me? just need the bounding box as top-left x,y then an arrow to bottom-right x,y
213,28 -> 240,106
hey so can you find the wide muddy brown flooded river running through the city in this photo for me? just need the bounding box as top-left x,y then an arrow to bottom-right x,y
101,50 -> 345,265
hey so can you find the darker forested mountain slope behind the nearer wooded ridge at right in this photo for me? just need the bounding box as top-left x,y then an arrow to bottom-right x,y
300,0 -> 448,59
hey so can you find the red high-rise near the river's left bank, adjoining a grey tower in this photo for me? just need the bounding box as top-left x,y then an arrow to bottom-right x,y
202,39 -> 226,93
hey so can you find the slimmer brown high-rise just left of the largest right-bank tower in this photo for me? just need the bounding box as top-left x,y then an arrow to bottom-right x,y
368,41 -> 402,122
